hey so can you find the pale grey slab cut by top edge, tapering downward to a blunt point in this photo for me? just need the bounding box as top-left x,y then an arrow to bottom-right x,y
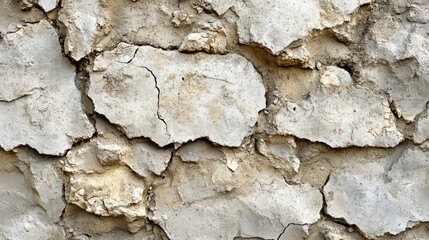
235,0 -> 370,55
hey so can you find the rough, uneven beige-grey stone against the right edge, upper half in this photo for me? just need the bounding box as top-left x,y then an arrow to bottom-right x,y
362,16 -> 429,122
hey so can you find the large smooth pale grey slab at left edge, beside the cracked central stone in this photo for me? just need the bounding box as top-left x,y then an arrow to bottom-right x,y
0,20 -> 94,155
